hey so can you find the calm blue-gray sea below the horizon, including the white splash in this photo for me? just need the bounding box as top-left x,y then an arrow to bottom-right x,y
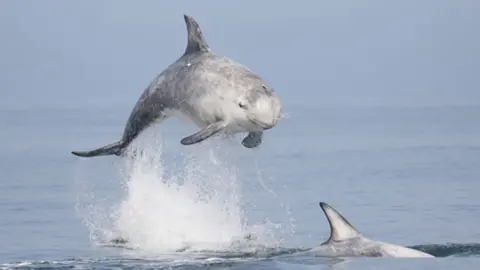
0,106 -> 480,269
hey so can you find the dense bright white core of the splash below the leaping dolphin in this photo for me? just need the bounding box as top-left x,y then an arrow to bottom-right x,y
115,142 -> 244,251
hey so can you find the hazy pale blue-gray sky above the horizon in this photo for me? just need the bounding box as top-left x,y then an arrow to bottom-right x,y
0,0 -> 480,109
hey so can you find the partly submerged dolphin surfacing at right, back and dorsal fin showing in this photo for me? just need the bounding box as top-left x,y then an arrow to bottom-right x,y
311,202 -> 433,258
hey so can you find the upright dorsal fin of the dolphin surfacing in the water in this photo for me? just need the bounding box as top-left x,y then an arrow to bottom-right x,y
320,202 -> 361,242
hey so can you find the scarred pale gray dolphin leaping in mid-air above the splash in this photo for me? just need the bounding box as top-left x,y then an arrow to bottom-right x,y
72,15 -> 282,157
